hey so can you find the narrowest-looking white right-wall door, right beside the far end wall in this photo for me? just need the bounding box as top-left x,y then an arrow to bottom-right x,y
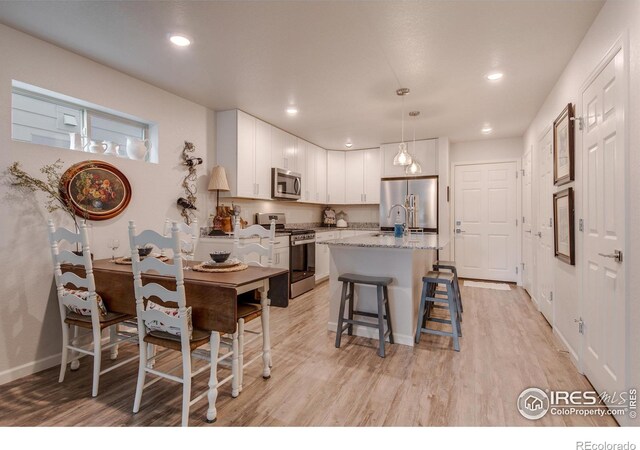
522,149 -> 535,295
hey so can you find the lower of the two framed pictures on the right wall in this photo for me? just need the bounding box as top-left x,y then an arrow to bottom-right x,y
553,188 -> 575,266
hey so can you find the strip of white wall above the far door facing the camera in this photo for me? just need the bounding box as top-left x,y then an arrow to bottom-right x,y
449,138 -> 524,166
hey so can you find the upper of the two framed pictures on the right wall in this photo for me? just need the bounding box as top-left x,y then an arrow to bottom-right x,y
553,103 -> 574,186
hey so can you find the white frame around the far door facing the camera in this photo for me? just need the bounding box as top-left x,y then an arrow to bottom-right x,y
449,157 -> 522,286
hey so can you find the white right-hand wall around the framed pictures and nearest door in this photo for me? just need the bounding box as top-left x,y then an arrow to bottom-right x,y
524,0 -> 640,404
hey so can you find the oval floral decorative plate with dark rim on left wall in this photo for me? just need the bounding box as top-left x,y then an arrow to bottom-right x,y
60,160 -> 131,220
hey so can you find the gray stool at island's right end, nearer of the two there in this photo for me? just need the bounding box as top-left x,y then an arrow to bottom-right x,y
416,272 -> 462,352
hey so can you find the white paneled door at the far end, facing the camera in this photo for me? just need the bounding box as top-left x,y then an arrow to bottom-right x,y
454,162 -> 519,281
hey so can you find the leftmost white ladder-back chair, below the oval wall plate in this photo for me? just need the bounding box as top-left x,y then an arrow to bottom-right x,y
48,219 -> 136,397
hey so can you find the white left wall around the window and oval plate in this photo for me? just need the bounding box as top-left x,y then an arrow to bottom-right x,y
0,25 -> 215,383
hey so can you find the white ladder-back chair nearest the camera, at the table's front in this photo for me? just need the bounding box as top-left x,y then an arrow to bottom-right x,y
129,221 -> 232,426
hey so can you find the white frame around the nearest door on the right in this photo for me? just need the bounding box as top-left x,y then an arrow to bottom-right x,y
576,30 -> 632,408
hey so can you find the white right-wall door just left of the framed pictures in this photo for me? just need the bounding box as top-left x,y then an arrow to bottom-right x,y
534,130 -> 555,326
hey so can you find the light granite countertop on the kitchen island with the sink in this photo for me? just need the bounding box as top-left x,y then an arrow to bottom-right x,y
319,233 -> 449,250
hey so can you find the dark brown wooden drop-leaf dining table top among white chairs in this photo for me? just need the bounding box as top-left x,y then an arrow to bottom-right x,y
63,259 -> 289,333
